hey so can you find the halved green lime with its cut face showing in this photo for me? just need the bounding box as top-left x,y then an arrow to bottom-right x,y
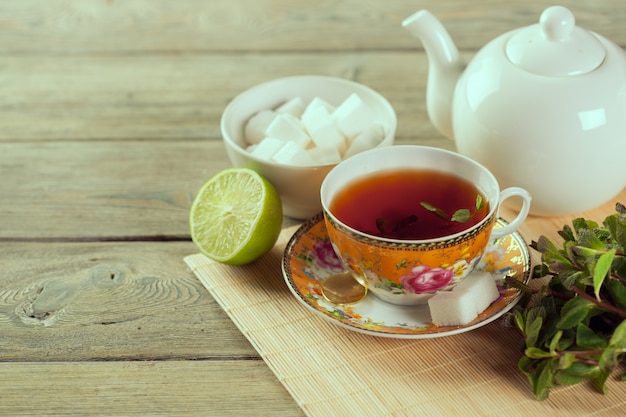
189,168 -> 283,265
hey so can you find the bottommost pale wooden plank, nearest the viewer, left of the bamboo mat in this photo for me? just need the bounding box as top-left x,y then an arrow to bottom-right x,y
0,360 -> 304,417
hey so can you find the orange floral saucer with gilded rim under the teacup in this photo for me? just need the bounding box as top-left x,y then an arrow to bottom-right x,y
282,213 -> 530,339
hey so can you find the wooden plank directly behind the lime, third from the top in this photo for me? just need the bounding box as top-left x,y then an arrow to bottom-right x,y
0,138 -> 452,242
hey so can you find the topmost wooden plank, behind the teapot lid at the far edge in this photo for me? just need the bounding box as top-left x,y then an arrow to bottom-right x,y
0,0 -> 626,54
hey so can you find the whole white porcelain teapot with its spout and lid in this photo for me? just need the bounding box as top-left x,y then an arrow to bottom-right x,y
403,6 -> 626,215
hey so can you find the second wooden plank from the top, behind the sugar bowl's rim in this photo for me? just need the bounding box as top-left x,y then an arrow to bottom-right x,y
0,52 -> 438,142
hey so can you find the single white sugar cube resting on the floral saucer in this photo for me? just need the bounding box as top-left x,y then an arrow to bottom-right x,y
428,271 -> 500,326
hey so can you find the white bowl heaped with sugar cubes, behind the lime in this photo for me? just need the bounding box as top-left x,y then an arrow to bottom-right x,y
221,75 -> 397,219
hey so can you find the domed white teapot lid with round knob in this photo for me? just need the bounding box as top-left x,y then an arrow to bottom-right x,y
506,6 -> 606,77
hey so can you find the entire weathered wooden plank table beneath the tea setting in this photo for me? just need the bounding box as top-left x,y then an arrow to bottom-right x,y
0,0 -> 626,416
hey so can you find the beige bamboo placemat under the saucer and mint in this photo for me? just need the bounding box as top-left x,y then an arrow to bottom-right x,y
185,226 -> 626,417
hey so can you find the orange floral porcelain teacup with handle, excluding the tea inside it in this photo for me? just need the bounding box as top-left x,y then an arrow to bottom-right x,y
320,145 -> 531,305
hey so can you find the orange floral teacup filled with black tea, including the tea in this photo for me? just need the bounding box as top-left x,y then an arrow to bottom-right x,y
320,145 -> 531,305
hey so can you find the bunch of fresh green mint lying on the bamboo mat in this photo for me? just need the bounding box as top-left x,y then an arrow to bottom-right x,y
507,203 -> 626,400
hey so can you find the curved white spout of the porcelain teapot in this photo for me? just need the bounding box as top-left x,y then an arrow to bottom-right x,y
402,10 -> 465,140
